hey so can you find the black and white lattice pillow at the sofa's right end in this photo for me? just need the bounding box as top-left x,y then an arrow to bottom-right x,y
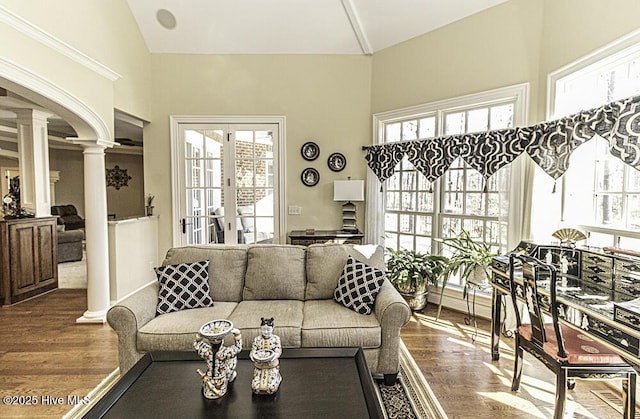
333,256 -> 385,314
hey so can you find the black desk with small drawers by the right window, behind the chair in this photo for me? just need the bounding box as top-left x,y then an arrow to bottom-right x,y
491,242 -> 640,365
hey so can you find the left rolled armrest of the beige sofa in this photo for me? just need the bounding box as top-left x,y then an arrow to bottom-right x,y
107,282 -> 158,376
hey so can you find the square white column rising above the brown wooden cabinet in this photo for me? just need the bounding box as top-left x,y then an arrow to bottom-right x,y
15,109 -> 51,217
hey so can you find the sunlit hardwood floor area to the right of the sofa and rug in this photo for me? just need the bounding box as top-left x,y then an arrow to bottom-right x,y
401,304 -> 622,419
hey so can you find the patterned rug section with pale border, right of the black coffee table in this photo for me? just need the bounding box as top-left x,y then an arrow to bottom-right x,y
378,340 -> 447,419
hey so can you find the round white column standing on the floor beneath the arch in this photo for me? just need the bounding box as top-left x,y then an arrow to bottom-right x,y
72,138 -> 113,323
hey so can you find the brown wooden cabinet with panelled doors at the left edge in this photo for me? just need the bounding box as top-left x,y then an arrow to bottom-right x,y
0,217 -> 58,305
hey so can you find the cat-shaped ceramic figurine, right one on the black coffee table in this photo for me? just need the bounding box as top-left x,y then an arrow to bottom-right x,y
249,317 -> 282,394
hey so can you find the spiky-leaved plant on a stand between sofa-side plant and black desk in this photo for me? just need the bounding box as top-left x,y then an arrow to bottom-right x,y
437,228 -> 497,317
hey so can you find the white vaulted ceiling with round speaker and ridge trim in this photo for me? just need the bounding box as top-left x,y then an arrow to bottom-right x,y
127,0 -> 507,54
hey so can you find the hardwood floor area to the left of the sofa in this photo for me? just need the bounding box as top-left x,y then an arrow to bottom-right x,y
0,289 -> 118,418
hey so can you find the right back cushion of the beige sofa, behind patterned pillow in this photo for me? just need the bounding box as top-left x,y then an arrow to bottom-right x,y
305,244 -> 386,300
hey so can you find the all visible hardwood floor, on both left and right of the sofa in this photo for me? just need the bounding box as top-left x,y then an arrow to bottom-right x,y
0,289 -> 632,419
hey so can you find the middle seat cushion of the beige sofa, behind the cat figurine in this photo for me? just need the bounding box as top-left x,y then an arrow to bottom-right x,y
229,300 -> 304,348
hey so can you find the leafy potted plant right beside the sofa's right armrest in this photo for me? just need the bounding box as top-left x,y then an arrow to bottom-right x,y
387,248 -> 449,311
